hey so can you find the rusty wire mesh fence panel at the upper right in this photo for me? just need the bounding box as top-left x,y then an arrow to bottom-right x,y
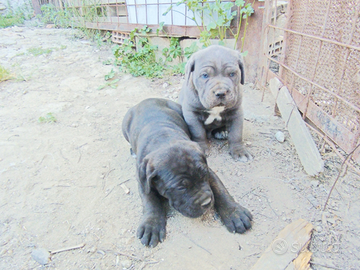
268,0 -> 360,164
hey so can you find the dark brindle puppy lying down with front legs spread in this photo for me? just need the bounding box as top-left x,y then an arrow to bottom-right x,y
122,98 -> 252,247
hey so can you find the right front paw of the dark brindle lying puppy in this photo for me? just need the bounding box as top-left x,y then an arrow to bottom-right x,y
219,203 -> 253,233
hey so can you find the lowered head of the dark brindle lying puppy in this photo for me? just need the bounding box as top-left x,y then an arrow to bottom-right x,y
139,141 -> 214,218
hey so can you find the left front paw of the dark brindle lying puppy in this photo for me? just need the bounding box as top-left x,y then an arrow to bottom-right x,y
136,216 -> 166,247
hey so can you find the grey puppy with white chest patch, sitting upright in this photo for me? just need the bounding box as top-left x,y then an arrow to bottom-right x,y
179,45 -> 252,162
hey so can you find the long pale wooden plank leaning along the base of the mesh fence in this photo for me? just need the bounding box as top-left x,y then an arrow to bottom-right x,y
270,78 -> 324,176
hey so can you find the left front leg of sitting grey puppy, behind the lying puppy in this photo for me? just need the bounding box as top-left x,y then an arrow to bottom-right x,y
183,111 -> 210,155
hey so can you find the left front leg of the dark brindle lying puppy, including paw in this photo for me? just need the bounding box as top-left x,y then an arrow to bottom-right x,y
137,187 -> 166,247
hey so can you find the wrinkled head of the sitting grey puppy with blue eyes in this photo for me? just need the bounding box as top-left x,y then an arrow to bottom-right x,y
185,45 -> 245,109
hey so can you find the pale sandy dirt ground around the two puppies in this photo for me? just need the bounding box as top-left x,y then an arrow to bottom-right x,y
0,27 -> 360,270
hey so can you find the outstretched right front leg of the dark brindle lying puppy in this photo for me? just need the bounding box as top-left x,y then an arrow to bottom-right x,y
209,168 -> 252,233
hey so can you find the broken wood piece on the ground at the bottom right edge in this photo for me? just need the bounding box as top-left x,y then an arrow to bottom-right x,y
251,219 -> 313,270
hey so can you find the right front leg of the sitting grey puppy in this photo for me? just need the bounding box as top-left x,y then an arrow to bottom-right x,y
228,108 -> 253,162
